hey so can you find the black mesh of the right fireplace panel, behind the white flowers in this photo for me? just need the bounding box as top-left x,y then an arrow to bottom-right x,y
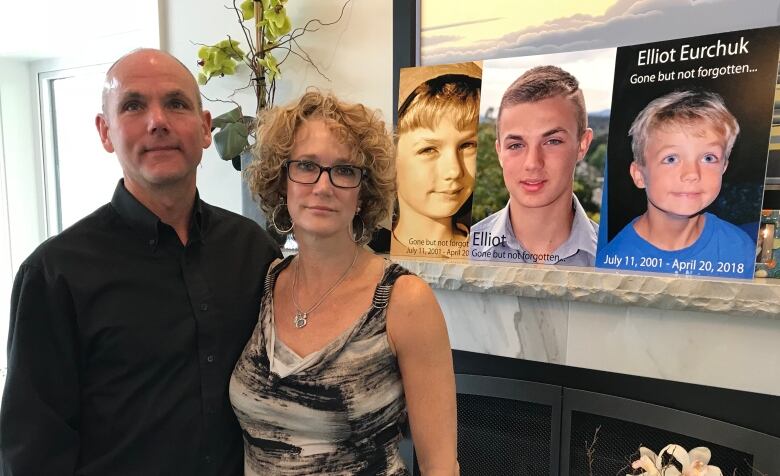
569,412 -> 761,476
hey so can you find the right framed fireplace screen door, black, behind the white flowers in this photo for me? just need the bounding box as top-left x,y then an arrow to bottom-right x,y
561,388 -> 780,476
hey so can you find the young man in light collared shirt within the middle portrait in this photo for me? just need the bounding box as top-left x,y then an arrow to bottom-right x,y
470,66 -> 598,266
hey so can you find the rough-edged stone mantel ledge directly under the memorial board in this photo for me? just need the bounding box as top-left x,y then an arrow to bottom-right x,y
395,258 -> 780,319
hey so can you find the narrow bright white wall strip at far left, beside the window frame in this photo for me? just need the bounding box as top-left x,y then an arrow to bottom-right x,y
0,58 -> 45,270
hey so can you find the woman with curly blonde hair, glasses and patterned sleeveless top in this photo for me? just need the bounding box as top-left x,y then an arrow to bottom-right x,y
235,91 -> 457,475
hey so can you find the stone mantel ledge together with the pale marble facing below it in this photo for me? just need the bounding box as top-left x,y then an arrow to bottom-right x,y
394,258 -> 780,396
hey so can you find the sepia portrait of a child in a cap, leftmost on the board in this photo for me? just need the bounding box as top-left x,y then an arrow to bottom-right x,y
391,63 -> 482,258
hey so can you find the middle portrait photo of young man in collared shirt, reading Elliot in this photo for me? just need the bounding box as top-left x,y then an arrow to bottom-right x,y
469,49 -> 615,267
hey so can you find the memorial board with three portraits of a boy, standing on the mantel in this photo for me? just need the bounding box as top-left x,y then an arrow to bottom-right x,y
391,27 -> 780,279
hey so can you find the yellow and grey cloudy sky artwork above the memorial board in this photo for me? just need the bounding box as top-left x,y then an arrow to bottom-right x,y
420,0 -> 780,65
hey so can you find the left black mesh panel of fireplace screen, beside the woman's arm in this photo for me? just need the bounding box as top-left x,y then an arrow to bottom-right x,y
458,394 -> 552,476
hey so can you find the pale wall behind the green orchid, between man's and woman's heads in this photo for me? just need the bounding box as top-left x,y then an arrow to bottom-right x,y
161,0 -> 393,213
